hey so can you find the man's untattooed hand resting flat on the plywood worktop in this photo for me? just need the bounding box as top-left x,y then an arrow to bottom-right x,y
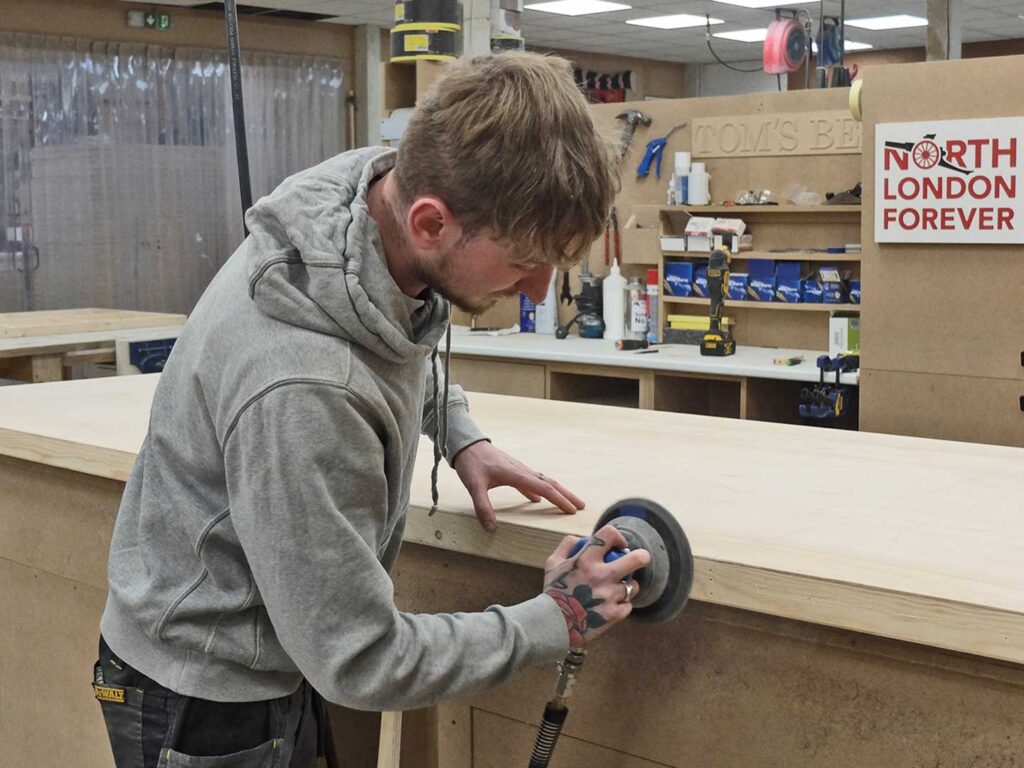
455,440 -> 586,531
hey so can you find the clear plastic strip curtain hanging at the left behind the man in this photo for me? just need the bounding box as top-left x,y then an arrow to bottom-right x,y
0,34 -> 346,312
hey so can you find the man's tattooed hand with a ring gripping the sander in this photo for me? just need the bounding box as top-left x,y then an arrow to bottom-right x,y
544,524 -> 650,647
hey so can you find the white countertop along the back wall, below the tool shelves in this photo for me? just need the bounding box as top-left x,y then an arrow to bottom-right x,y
442,326 -> 860,385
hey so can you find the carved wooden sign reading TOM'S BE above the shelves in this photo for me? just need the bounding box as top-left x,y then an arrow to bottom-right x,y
692,110 -> 860,160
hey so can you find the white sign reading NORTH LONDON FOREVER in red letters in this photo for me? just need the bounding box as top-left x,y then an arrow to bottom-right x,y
874,118 -> 1024,243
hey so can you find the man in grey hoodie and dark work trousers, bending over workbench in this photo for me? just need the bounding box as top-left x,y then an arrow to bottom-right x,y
94,54 -> 647,768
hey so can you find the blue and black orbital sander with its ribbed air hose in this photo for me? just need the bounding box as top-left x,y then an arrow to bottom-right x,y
529,499 -> 693,768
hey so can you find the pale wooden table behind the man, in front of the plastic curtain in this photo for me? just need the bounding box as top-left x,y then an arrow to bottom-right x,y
0,308 -> 185,383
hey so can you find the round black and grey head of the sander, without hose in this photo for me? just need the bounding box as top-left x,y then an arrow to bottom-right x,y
594,499 -> 693,623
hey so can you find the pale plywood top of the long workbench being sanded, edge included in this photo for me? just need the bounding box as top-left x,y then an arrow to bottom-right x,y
0,375 -> 1024,664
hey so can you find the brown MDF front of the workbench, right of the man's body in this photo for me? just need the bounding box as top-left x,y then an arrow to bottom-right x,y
395,546 -> 1024,768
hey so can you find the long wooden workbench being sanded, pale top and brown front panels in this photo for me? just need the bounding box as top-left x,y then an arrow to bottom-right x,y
0,376 -> 1024,768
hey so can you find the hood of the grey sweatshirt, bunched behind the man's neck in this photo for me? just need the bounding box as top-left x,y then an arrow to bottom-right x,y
246,147 -> 449,362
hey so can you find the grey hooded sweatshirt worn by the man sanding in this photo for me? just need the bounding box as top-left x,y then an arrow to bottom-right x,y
101,148 -> 568,710
